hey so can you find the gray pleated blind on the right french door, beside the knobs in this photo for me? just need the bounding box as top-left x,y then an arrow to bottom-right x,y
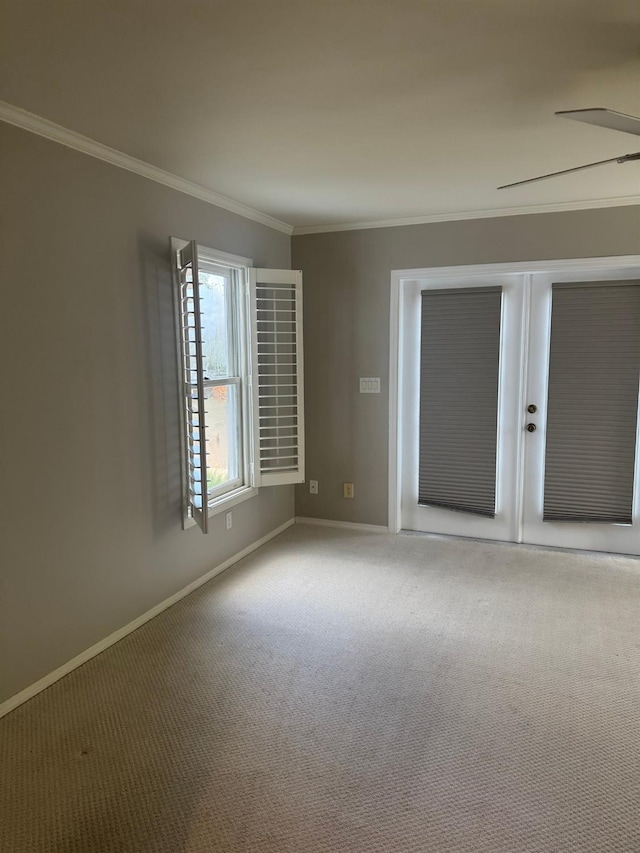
543,281 -> 640,524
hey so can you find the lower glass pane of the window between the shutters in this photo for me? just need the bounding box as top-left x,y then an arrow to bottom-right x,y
204,385 -> 241,495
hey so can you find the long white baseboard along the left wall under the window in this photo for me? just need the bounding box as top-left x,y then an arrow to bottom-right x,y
0,518 -> 295,717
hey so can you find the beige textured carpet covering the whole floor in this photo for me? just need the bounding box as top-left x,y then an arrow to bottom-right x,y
0,526 -> 640,853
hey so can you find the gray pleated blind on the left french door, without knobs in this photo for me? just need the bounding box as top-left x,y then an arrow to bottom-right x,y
418,287 -> 502,518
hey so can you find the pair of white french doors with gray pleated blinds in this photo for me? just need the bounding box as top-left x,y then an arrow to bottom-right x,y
391,259 -> 640,554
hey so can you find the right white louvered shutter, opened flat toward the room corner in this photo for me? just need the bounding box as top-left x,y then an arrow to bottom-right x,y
249,269 -> 304,486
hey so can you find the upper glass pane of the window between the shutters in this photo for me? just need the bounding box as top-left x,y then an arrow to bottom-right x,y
200,270 -> 233,379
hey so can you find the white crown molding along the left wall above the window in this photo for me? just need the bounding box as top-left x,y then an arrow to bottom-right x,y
0,101 -> 293,235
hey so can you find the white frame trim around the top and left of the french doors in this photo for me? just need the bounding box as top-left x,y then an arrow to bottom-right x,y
389,255 -> 640,541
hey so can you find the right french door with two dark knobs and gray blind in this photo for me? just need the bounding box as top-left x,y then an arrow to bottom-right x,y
522,268 -> 640,554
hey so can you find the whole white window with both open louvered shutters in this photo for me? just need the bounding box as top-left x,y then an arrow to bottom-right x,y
172,239 -> 304,533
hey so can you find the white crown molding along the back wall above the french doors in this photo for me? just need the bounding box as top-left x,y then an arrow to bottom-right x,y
293,195 -> 640,237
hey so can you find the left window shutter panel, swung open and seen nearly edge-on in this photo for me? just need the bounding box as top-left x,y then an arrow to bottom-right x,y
178,242 -> 208,533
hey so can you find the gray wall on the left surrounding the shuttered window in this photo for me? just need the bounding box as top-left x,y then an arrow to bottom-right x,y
0,124 -> 293,701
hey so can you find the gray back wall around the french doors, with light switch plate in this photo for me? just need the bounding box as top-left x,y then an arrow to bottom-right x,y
292,207 -> 640,525
